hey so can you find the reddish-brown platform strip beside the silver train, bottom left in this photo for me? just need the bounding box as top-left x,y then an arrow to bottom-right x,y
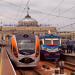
1,48 -> 16,75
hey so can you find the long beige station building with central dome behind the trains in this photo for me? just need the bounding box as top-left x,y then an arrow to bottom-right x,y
0,14 -> 57,40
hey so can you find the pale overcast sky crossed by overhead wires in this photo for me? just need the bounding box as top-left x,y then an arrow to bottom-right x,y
0,0 -> 75,31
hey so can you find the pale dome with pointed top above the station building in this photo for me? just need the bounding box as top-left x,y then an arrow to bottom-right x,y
18,14 -> 38,27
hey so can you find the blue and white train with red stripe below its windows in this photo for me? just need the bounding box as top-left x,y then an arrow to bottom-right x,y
40,34 -> 62,61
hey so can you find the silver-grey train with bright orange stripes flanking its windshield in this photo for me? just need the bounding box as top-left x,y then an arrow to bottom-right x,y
7,34 -> 40,67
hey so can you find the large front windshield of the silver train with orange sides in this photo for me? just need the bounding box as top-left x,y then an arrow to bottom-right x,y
18,40 -> 35,55
